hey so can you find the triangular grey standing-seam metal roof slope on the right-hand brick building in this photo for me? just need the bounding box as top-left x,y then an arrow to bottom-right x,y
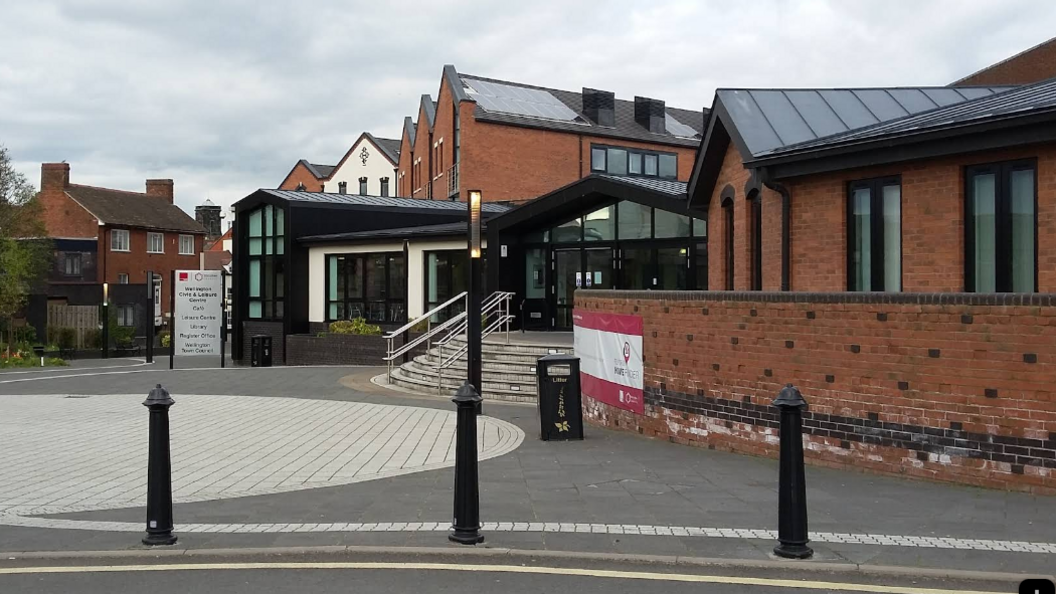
716,87 -> 1013,159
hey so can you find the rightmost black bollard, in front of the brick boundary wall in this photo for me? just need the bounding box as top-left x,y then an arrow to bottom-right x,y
773,384 -> 814,559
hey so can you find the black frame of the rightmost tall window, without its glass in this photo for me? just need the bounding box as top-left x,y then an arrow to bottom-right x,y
963,157 -> 1038,293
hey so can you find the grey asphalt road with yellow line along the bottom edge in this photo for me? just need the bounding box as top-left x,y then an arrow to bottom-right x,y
0,554 -> 1018,594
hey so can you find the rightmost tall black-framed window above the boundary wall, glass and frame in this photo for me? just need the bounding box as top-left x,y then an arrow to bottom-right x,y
964,161 -> 1038,293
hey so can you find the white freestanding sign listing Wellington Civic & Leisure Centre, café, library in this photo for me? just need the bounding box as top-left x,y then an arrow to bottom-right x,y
172,271 -> 224,355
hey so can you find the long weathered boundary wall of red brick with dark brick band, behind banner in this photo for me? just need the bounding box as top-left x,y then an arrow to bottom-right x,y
576,291 -> 1056,494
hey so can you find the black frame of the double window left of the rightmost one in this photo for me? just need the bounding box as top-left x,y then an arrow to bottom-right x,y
844,174 -> 905,293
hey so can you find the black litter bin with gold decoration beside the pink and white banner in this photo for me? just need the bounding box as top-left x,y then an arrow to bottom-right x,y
535,355 -> 583,442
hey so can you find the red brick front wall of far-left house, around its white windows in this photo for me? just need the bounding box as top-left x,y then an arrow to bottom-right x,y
97,224 -> 205,313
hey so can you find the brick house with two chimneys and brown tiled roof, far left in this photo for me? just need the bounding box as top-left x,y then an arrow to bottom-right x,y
37,163 -> 206,321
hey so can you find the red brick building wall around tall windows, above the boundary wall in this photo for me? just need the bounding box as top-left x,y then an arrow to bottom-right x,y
708,145 -> 1056,293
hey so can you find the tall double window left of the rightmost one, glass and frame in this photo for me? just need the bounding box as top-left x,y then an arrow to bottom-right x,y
847,178 -> 902,292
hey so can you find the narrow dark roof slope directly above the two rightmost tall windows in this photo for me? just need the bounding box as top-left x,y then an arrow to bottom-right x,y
772,79 -> 1056,155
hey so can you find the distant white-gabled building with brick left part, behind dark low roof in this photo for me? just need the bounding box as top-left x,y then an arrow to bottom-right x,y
279,132 -> 400,197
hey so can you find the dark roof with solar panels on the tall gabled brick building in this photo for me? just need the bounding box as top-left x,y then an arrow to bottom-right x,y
458,74 -> 705,148
